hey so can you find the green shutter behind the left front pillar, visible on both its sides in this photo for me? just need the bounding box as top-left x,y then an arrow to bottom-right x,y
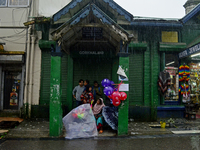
40,50 -> 67,105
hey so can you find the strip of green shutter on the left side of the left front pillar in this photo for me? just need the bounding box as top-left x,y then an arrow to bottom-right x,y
40,50 -> 51,105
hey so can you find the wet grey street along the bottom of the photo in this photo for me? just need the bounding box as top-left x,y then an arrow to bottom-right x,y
0,134 -> 200,150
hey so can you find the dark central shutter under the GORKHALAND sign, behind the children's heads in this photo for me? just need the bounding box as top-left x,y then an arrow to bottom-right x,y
74,58 -> 112,86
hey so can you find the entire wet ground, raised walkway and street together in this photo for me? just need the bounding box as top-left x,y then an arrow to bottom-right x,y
0,118 -> 200,150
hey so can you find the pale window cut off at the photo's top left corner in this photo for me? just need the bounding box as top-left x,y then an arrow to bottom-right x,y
0,0 -> 29,7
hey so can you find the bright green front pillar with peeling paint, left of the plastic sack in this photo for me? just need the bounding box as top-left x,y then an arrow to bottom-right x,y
49,56 -> 62,137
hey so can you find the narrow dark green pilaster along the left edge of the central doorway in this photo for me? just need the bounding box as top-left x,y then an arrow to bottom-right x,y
67,55 -> 74,111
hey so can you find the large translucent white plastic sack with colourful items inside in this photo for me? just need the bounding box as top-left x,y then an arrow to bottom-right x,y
63,104 -> 98,139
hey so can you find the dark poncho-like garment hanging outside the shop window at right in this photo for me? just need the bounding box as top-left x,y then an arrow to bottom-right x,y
158,70 -> 171,95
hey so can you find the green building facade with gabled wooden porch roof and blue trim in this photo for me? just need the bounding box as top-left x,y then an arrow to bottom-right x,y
25,0 -> 200,125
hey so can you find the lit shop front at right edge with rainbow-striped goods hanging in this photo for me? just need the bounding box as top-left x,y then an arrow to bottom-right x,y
178,43 -> 200,119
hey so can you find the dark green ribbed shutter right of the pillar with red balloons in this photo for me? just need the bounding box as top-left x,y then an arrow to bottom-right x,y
129,51 -> 144,106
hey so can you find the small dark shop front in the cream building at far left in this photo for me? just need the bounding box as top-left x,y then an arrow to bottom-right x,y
0,52 -> 25,111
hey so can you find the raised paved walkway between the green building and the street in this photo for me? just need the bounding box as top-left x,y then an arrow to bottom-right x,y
2,119 -> 200,138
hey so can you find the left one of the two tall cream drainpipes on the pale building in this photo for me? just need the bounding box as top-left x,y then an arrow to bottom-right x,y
24,26 -> 31,114
